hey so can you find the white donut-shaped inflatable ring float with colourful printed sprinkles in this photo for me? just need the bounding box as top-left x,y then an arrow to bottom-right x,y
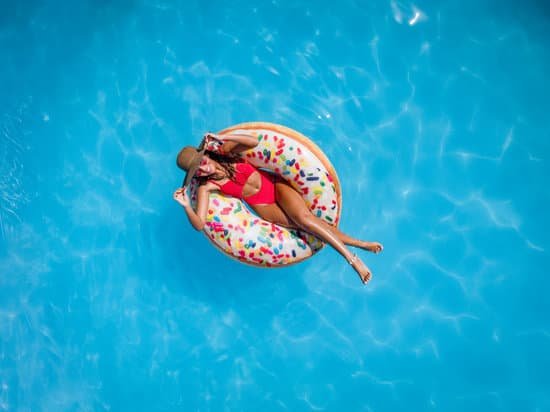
189,122 -> 342,267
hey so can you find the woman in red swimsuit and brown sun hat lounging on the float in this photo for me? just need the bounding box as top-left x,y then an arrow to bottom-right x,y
174,133 -> 382,283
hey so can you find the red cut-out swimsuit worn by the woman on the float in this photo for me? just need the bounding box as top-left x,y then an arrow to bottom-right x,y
211,163 -> 275,205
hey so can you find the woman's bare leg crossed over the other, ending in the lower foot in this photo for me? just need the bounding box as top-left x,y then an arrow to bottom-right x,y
275,182 -> 371,283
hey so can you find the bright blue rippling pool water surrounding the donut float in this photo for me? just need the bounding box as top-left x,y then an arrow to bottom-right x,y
0,0 -> 550,412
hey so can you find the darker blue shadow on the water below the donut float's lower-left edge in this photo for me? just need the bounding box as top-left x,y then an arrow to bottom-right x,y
151,206 -> 306,320
